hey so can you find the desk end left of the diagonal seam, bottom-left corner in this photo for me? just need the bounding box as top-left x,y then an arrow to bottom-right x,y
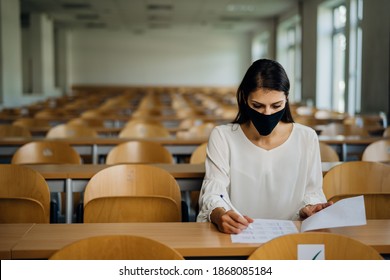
0,224 -> 33,260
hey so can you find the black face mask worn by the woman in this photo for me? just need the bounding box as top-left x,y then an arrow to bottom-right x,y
247,106 -> 286,136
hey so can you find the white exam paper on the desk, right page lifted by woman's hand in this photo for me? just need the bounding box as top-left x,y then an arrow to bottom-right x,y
230,196 -> 367,243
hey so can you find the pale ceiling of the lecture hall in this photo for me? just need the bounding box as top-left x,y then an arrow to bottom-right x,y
20,0 -> 297,33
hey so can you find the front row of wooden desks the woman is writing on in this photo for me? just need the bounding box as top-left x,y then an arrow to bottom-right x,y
0,220 -> 390,259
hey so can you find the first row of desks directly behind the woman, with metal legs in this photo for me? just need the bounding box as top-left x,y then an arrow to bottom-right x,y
25,162 -> 341,223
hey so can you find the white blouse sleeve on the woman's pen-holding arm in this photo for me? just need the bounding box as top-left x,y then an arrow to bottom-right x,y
197,127 -> 230,222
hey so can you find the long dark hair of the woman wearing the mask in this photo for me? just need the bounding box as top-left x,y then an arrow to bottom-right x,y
233,59 -> 294,124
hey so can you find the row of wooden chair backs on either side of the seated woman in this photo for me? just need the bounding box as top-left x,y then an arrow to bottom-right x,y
0,161 -> 390,223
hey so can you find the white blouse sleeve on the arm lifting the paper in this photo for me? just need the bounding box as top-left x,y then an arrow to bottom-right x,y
297,132 -> 326,217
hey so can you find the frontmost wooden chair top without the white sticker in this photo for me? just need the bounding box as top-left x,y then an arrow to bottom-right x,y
50,235 -> 184,260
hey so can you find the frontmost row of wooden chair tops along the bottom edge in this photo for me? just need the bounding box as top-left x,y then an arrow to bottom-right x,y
50,232 -> 383,260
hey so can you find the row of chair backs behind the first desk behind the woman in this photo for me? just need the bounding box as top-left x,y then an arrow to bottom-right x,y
5,139 -> 390,164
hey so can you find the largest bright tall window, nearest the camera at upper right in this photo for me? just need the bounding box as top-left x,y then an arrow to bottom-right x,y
316,0 -> 363,115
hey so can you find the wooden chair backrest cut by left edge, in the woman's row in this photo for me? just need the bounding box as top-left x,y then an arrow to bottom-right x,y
0,164 -> 50,223
